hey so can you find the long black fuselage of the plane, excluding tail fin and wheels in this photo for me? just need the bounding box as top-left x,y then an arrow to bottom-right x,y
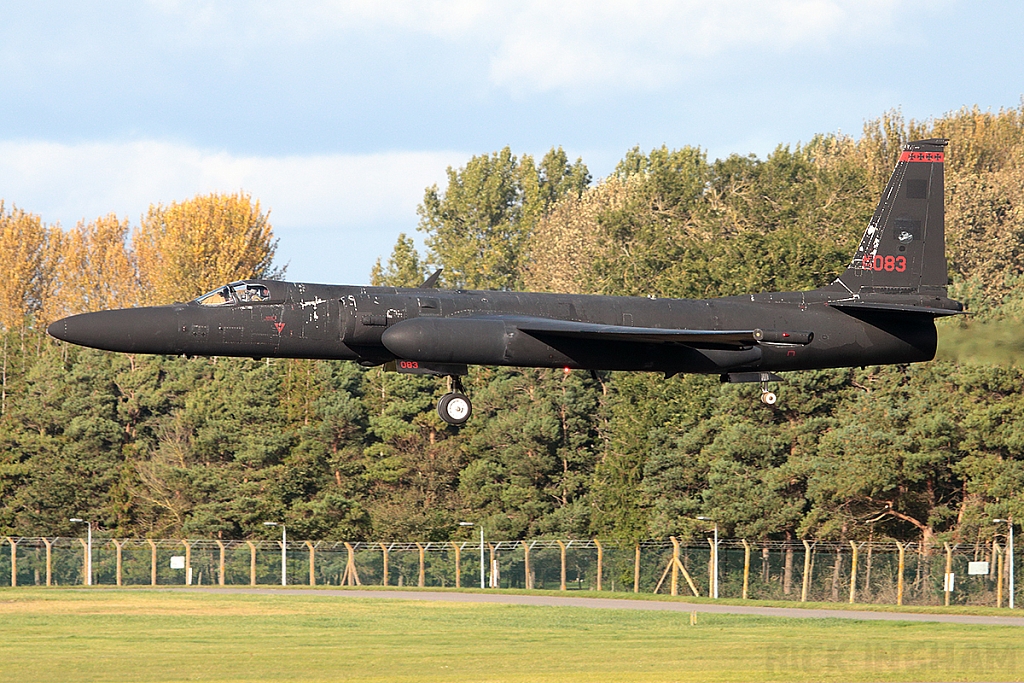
51,281 -> 953,374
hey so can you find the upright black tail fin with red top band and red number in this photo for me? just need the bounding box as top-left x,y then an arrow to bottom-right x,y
829,139 -> 948,297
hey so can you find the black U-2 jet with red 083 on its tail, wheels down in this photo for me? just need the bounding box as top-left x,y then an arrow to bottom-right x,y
49,139 -> 963,425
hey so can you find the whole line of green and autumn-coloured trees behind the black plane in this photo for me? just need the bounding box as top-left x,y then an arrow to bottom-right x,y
0,108 -> 1024,543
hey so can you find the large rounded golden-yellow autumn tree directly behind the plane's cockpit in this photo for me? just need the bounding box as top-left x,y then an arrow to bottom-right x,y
132,193 -> 281,304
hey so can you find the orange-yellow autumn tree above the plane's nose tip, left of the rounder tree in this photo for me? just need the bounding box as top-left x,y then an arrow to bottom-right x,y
42,214 -> 139,323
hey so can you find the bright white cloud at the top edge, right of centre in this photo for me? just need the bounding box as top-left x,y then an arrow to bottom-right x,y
490,0 -> 905,91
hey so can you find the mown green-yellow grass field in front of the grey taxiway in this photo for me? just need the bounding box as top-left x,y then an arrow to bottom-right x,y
0,588 -> 1024,683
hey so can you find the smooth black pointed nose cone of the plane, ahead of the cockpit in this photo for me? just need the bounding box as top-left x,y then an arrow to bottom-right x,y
46,306 -> 176,353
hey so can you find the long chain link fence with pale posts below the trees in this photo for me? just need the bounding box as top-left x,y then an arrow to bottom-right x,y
0,535 -> 1020,606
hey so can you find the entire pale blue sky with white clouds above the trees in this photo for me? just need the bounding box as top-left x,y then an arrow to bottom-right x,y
0,0 -> 1024,283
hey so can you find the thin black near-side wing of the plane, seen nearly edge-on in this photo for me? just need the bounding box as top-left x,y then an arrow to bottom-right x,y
501,315 -> 759,348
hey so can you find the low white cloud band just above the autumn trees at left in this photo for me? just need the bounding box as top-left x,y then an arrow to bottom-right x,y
0,141 -> 466,227
